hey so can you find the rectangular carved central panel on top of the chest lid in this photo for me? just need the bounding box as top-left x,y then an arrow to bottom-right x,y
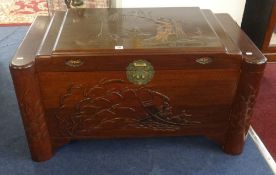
54,7 -> 224,53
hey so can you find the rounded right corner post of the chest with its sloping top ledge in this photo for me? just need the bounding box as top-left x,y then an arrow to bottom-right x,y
217,14 -> 267,154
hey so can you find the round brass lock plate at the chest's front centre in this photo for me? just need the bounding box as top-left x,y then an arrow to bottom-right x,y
126,60 -> 154,85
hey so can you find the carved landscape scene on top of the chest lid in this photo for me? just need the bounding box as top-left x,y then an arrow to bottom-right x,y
69,10 -> 220,48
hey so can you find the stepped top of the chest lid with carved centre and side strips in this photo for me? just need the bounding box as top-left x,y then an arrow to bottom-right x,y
38,7 -> 240,56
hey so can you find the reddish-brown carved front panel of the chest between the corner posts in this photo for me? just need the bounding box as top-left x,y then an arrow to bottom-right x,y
39,67 -> 239,138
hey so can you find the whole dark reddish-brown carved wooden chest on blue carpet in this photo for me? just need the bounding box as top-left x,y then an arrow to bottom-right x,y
10,8 -> 266,161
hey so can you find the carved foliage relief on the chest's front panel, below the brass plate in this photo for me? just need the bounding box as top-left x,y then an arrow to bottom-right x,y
55,79 -> 199,136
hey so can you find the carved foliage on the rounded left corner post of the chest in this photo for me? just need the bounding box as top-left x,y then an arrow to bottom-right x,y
12,67 -> 49,145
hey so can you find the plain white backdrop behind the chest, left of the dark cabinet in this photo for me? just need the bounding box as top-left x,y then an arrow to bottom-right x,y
116,0 -> 246,24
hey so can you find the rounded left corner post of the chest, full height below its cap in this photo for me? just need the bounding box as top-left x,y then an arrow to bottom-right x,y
11,67 -> 53,161
